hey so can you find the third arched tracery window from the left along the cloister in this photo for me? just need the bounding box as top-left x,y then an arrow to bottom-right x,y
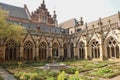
39,42 -> 47,60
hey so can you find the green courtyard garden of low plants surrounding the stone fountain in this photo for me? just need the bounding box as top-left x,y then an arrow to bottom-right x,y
0,60 -> 120,80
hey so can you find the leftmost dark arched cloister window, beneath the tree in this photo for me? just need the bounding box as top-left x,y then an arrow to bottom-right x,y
5,40 -> 18,61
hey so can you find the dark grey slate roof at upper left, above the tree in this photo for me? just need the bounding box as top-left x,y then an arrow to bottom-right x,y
0,3 -> 29,19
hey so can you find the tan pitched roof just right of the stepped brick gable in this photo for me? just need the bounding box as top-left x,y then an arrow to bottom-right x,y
59,18 -> 77,29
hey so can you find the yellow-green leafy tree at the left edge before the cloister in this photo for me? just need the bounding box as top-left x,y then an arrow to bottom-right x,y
0,9 -> 24,44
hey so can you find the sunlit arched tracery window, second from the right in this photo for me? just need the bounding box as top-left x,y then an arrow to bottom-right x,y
91,39 -> 100,58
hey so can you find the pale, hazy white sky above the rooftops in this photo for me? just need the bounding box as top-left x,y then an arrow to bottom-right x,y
0,0 -> 120,23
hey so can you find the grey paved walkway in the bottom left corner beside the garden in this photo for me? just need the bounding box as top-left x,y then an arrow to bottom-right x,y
0,67 -> 17,80
